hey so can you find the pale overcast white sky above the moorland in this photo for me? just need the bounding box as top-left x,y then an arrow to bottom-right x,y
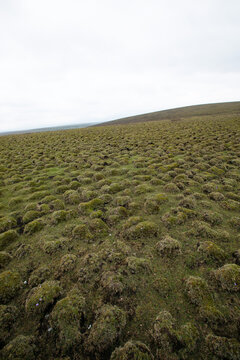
0,0 -> 240,132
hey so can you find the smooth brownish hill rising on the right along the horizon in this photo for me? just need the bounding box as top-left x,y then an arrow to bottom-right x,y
94,101 -> 240,126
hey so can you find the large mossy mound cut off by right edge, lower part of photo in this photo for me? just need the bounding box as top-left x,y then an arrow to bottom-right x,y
213,264 -> 240,292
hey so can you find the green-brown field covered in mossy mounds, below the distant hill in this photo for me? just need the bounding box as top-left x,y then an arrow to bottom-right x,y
0,114 -> 240,360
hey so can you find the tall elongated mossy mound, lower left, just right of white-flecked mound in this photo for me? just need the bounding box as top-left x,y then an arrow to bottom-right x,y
50,289 -> 86,352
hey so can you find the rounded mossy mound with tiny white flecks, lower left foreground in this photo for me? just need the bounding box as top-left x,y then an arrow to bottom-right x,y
25,281 -> 62,315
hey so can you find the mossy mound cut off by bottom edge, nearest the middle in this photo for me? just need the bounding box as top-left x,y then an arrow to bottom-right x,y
110,341 -> 154,360
